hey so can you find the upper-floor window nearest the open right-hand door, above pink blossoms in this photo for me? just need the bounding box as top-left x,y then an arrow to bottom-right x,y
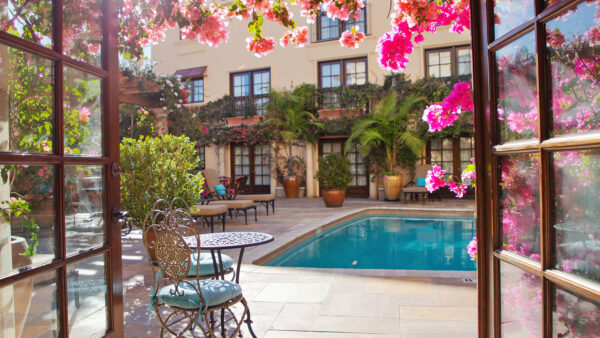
425,46 -> 471,78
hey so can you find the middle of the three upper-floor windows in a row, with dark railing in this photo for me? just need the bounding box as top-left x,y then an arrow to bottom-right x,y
319,58 -> 367,108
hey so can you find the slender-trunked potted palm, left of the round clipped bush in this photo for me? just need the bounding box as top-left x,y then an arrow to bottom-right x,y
267,90 -> 323,198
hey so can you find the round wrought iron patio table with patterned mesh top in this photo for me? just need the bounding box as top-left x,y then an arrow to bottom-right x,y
185,232 -> 274,337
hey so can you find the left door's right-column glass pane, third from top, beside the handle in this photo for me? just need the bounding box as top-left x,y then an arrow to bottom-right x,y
65,165 -> 106,255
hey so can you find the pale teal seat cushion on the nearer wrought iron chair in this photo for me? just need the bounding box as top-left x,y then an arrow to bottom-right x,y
156,279 -> 242,309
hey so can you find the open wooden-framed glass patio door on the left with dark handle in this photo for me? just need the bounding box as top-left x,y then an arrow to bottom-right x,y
0,0 -> 123,338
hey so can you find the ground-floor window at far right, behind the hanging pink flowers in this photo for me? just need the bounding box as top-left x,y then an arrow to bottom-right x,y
428,137 -> 475,176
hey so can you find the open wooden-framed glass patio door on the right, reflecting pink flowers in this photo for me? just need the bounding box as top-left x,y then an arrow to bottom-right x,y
472,0 -> 600,337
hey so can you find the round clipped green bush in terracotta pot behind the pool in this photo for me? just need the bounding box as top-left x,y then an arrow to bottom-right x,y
315,153 -> 352,190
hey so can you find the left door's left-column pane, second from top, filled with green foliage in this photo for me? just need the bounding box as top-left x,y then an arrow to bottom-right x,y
0,44 -> 54,154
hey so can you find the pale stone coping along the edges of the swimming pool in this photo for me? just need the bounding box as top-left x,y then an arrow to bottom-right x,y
248,207 -> 476,278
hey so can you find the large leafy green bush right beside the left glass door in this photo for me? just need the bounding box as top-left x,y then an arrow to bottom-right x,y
121,135 -> 204,227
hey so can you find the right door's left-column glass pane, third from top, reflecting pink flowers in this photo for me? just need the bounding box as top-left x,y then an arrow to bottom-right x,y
498,154 -> 540,261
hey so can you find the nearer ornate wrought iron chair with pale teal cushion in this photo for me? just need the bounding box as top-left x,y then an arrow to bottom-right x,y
144,210 -> 249,337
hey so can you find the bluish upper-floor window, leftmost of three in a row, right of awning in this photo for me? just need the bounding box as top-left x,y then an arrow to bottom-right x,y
231,69 -> 271,115
